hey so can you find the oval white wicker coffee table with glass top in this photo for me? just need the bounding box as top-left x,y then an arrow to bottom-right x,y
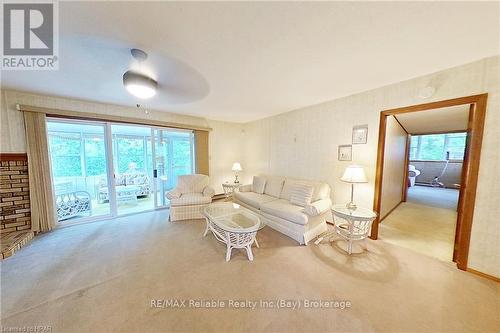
203,202 -> 265,261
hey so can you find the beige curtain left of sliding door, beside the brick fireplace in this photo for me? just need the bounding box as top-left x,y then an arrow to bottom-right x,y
24,112 -> 57,232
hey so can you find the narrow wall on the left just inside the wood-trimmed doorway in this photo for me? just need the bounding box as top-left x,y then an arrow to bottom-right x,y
380,116 -> 408,217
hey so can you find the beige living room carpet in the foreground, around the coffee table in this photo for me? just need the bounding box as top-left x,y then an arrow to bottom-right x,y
1,212 -> 500,332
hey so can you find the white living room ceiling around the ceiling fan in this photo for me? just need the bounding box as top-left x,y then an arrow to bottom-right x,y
2,2 -> 500,122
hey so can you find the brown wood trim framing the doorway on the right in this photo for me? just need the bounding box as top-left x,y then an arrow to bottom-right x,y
370,94 -> 488,270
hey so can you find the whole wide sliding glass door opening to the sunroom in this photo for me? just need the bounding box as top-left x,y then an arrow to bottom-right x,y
47,119 -> 194,221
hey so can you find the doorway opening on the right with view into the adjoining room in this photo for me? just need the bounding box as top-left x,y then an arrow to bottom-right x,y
379,131 -> 462,261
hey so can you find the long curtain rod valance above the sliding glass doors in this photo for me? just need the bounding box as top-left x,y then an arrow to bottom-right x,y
16,104 -> 212,132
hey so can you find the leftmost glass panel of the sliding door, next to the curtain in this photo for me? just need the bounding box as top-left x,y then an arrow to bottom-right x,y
47,120 -> 112,221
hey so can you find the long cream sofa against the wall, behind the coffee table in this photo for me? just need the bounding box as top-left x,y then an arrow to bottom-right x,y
233,176 -> 332,245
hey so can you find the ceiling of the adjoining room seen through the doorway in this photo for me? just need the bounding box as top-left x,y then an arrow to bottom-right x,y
395,105 -> 470,134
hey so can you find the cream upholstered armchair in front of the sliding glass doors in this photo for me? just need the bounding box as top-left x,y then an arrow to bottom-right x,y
166,174 -> 215,221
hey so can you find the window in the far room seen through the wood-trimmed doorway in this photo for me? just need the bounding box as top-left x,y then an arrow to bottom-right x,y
410,133 -> 467,161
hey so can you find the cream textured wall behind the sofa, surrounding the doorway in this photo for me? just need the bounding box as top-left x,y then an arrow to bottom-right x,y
244,56 -> 500,276
